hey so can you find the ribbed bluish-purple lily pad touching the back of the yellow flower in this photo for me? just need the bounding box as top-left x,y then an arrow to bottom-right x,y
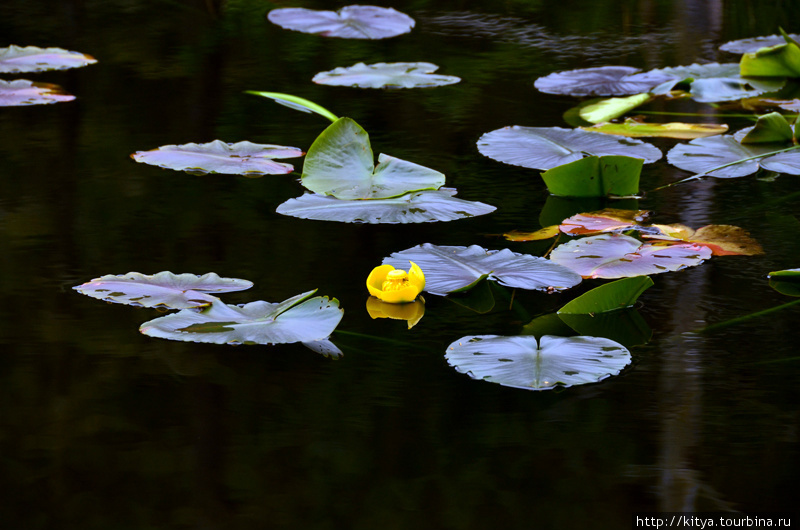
383,243 -> 581,296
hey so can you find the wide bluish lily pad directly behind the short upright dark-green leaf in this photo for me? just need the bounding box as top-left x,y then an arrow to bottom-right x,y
478,125 -> 661,170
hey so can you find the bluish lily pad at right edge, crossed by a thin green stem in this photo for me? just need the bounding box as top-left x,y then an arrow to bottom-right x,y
667,135 -> 800,178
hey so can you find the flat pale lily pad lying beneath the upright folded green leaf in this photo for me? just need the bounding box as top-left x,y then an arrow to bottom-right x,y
277,188 -> 496,224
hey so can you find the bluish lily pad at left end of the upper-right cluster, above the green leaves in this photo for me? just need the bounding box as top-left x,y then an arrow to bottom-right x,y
533,66 -> 674,96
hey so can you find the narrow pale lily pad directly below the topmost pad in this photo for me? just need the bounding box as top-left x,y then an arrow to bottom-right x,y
312,63 -> 461,88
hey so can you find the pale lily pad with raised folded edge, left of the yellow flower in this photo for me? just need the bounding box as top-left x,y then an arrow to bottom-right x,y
139,290 -> 343,342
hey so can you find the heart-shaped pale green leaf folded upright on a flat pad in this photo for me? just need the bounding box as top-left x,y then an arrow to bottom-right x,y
301,118 -> 445,199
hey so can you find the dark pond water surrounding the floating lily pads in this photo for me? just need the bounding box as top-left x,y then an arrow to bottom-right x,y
0,0 -> 800,529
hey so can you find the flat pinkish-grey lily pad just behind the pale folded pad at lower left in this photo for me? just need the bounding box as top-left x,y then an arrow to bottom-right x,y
73,271 -> 253,309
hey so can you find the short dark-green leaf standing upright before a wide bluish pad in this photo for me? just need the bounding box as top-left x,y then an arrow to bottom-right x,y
542,156 -> 644,197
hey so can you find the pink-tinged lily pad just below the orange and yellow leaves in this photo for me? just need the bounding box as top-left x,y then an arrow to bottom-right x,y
550,234 -> 711,278
